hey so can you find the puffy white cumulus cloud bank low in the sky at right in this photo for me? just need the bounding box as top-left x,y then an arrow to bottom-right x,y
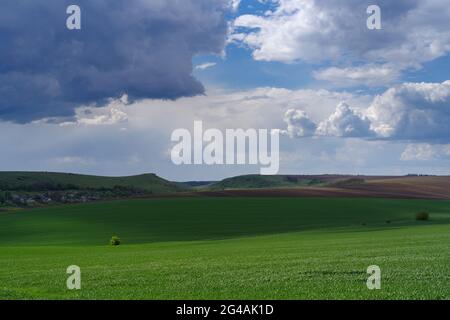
284,81 -> 450,144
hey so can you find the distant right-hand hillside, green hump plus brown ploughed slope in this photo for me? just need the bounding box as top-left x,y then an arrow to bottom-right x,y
202,175 -> 450,199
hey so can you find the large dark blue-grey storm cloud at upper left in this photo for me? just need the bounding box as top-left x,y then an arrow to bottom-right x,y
0,0 -> 228,122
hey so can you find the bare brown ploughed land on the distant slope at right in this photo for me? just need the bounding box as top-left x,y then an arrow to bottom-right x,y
189,177 -> 450,200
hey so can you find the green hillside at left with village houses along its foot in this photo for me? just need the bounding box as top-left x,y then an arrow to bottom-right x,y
0,172 -> 189,206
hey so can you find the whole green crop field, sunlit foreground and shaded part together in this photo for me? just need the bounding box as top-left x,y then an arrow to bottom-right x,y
0,198 -> 450,299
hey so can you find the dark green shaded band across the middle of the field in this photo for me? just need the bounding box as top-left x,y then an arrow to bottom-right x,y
0,198 -> 450,245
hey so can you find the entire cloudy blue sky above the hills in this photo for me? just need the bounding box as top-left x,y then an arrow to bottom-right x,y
0,0 -> 450,181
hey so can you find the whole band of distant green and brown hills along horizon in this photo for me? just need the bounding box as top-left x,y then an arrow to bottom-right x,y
0,172 -> 450,202
